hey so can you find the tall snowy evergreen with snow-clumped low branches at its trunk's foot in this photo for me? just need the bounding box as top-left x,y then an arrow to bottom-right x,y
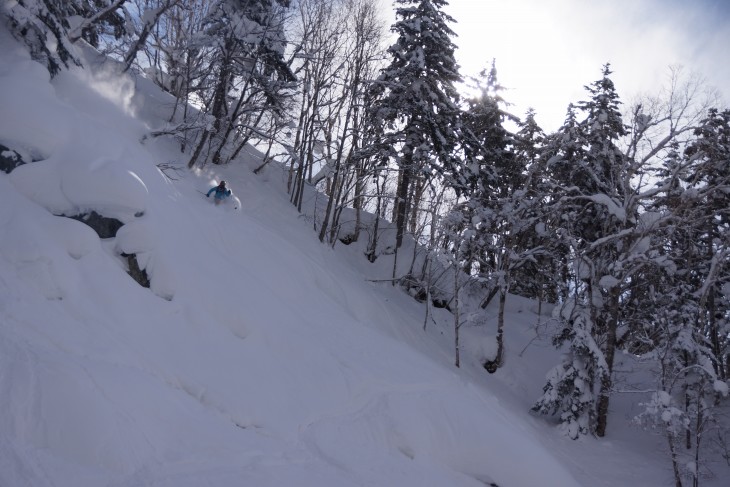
534,65 -> 638,436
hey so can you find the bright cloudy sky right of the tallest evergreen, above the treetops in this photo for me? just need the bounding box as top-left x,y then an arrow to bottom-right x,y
440,0 -> 730,131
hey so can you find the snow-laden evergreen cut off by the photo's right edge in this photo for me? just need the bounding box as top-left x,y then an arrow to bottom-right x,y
637,109 -> 730,487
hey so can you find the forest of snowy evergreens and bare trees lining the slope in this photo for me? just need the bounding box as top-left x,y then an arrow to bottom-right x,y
0,0 -> 730,486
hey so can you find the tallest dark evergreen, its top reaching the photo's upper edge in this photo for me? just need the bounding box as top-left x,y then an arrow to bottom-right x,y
370,0 -> 460,247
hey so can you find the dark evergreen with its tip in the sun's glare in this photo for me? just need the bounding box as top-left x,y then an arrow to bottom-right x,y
447,63 -> 545,372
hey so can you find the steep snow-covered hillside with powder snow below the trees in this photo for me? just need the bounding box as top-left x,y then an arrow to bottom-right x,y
0,32 -> 721,487
